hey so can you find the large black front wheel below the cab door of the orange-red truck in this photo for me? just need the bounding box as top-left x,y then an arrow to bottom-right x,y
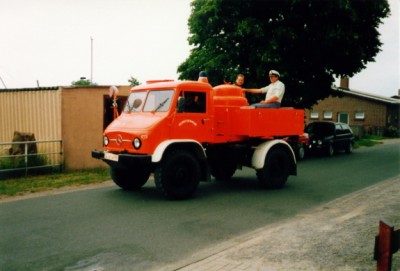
154,150 -> 200,200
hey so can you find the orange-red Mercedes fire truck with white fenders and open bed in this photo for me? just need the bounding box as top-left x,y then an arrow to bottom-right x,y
92,80 -> 304,199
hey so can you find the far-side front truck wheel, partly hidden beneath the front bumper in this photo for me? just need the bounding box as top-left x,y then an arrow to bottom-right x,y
110,167 -> 150,190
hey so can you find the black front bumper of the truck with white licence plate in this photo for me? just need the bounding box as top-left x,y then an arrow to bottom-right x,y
92,150 -> 151,168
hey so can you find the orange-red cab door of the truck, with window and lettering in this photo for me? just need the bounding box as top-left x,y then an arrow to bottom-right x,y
171,90 -> 216,142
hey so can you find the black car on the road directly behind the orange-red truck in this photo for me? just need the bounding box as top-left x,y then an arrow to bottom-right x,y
305,121 -> 354,156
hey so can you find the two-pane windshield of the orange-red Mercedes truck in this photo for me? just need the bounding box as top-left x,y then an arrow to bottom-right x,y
124,90 -> 174,113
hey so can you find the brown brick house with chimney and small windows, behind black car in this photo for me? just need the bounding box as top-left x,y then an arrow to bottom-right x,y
305,79 -> 400,137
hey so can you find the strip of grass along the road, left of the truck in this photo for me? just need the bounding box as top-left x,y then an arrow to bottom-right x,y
0,168 -> 110,199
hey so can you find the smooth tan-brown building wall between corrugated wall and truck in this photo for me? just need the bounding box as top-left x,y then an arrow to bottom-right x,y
62,86 -> 131,169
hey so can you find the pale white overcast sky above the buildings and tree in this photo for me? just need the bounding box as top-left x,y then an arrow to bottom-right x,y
0,0 -> 400,97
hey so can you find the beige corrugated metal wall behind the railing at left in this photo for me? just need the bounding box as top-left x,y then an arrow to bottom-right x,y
0,87 -> 62,163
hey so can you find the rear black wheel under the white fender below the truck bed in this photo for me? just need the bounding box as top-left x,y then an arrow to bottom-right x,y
257,148 -> 290,188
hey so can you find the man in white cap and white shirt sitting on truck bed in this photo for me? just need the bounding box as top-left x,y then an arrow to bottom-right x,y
243,70 -> 285,108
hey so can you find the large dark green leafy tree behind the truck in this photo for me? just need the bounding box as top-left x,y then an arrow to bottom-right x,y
178,0 -> 390,108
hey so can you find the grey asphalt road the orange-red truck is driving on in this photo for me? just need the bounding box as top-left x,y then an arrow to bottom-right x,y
0,144 -> 400,271
